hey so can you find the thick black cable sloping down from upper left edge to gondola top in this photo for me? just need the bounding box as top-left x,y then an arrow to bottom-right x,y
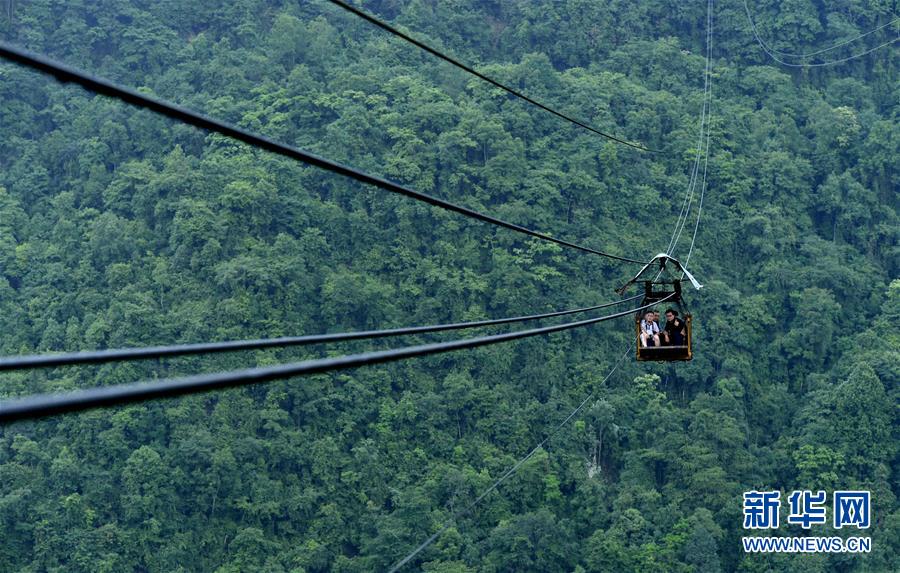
0,42 -> 644,265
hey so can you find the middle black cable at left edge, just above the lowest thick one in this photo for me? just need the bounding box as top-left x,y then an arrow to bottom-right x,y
0,295 -> 641,371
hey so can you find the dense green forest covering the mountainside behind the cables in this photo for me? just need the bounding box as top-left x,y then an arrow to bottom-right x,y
0,0 -> 900,573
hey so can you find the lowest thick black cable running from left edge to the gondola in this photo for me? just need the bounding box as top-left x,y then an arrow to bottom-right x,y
0,295 -> 673,423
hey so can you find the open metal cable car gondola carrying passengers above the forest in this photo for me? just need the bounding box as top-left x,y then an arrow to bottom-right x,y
617,253 -> 703,362
